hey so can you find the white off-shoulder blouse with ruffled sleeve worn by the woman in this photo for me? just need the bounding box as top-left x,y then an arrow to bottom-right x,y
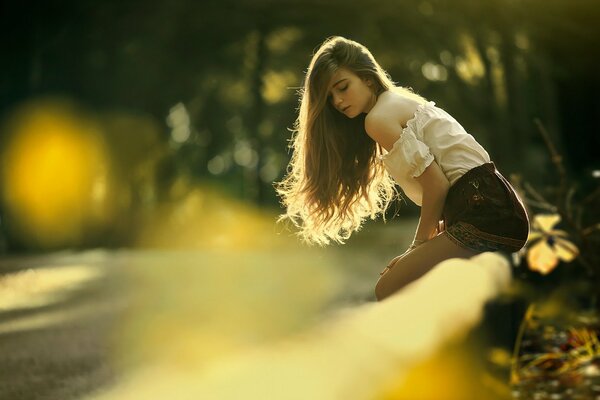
380,101 -> 490,206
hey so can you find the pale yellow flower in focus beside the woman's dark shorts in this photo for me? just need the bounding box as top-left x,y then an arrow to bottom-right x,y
527,214 -> 579,275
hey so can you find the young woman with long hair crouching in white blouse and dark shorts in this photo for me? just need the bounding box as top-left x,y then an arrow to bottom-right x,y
276,37 -> 529,300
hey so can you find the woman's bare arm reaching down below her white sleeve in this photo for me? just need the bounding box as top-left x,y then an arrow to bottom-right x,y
415,161 -> 450,241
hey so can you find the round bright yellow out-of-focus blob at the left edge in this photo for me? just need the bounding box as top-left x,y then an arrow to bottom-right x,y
1,101 -> 108,247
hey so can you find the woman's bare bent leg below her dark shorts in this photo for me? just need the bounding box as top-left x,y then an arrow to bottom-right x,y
375,232 -> 478,301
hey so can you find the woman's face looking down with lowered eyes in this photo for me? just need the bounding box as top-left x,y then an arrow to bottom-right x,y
329,68 -> 377,118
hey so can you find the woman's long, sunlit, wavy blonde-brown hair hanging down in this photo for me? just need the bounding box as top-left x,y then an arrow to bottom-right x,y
275,36 -> 424,245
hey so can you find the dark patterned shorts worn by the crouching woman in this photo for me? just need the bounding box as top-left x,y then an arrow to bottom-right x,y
442,162 -> 529,253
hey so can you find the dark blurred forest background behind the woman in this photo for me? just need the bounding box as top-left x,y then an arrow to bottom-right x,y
0,0 -> 600,254
